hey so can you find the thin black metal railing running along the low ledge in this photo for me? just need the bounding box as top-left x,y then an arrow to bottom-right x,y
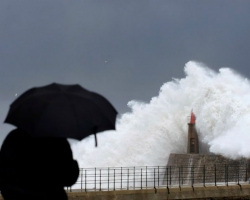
67,164 -> 249,192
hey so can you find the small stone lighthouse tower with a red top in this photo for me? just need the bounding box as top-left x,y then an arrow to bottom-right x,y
187,111 -> 199,153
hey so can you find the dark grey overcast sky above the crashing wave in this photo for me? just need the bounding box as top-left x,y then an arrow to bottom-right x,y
0,0 -> 250,141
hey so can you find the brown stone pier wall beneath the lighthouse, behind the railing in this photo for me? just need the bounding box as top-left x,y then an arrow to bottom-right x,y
163,154 -> 250,185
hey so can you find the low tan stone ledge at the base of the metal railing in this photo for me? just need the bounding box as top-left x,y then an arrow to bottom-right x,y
68,184 -> 250,200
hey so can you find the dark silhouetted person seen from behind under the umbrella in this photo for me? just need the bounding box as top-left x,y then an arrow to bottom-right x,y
0,129 -> 79,200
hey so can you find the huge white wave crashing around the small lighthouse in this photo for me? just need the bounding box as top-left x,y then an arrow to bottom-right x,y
72,61 -> 250,167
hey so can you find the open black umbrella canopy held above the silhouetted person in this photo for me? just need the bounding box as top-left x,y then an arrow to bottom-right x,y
5,83 -> 117,144
